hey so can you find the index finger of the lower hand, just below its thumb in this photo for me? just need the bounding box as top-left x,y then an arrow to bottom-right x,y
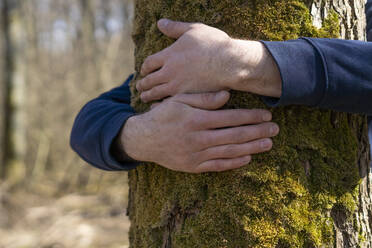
200,109 -> 272,129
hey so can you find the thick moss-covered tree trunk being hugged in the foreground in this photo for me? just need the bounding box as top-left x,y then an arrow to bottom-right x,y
128,0 -> 372,248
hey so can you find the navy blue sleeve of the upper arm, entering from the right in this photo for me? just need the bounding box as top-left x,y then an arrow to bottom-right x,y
263,38 -> 372,115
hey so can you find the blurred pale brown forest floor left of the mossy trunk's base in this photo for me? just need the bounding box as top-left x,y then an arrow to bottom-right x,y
0,182 -> 130,248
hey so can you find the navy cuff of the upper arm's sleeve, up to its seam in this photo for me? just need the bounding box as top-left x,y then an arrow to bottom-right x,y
262,38 -> 326,107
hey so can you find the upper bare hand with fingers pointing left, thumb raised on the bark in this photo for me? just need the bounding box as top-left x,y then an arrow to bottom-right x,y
136,19 -> 282,102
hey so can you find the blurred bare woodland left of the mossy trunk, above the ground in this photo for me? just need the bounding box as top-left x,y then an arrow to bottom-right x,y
0,0 -> 134,192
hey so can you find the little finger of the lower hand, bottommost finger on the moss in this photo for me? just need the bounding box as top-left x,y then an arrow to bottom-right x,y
195,156 -> 252,173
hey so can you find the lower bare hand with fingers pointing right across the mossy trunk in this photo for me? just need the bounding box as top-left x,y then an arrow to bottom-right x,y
120,91 -> 279,173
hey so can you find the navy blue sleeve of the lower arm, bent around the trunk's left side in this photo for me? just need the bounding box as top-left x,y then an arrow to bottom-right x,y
70,75 -> 138,171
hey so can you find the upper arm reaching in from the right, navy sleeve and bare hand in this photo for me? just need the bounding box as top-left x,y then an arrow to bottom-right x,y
137,19 -> 372,114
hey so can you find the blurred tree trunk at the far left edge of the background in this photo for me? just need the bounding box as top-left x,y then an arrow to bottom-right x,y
1,0 -> 26,178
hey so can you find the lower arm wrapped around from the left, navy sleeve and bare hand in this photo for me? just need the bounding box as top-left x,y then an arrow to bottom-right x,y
71,77 -> 279,173
